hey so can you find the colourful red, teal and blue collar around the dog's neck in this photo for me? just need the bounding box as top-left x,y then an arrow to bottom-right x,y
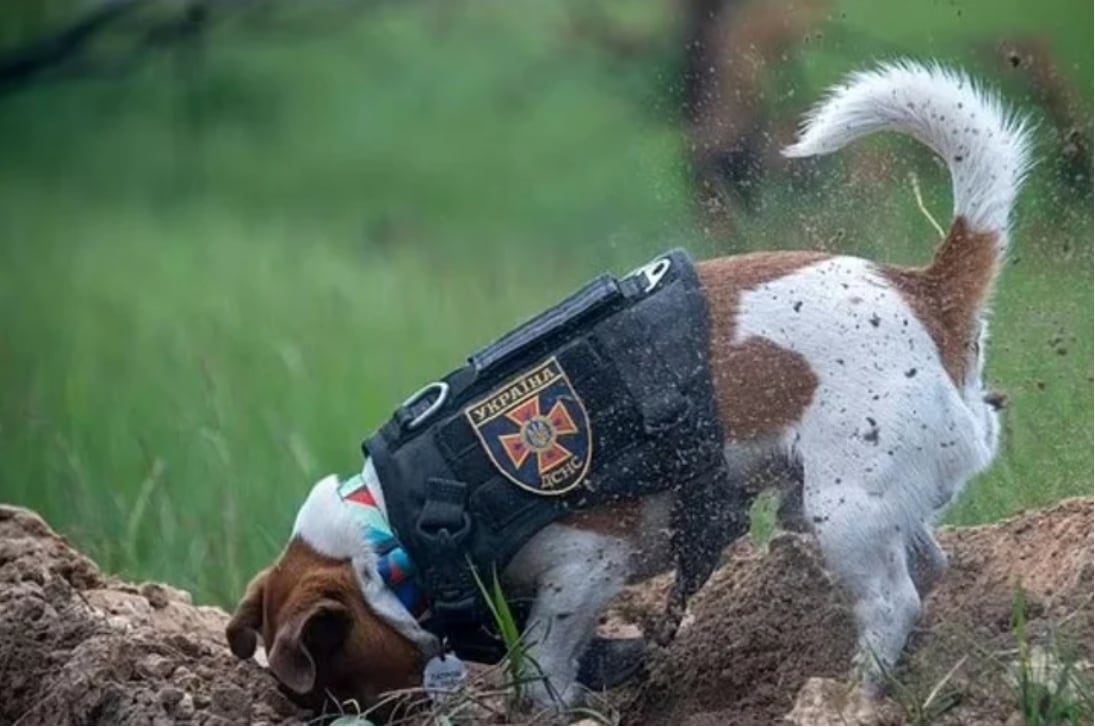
338,474 -> 425,621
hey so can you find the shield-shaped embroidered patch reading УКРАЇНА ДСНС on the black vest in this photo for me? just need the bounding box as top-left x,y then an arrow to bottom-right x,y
464,357 -> 592,495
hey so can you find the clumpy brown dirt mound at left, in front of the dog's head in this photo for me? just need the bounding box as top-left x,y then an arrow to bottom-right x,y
0,507 -> 309,725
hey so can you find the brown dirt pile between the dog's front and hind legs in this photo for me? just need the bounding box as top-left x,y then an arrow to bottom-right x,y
622,536 -> 855,725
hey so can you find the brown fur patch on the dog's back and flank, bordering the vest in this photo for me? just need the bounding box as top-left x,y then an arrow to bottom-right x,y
696,252 -> 830,440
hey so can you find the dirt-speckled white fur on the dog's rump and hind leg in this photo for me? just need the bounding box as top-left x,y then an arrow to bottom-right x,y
736,257 -> 999,676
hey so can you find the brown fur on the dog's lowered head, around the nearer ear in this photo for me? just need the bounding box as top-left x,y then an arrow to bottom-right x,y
228,538 -> 423,704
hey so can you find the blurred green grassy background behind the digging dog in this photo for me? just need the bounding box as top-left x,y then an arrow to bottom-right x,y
0,0 -> 1093,604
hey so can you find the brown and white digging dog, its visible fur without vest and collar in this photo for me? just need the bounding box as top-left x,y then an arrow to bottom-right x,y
228,62 -> 1028,704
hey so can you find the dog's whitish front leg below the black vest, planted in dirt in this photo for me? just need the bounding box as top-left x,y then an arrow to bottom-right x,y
506,524 -> 631,708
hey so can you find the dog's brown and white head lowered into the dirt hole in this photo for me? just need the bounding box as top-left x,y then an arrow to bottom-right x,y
226,481 -> 427,705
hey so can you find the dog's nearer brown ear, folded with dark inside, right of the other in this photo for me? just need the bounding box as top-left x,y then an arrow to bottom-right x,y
268,599 -> 353,694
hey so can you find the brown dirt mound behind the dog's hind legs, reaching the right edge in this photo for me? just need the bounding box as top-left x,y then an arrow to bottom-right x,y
612,499 -> 1093,725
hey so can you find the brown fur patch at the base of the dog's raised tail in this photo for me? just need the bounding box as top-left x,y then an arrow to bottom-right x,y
880,217 -> 1000,384
